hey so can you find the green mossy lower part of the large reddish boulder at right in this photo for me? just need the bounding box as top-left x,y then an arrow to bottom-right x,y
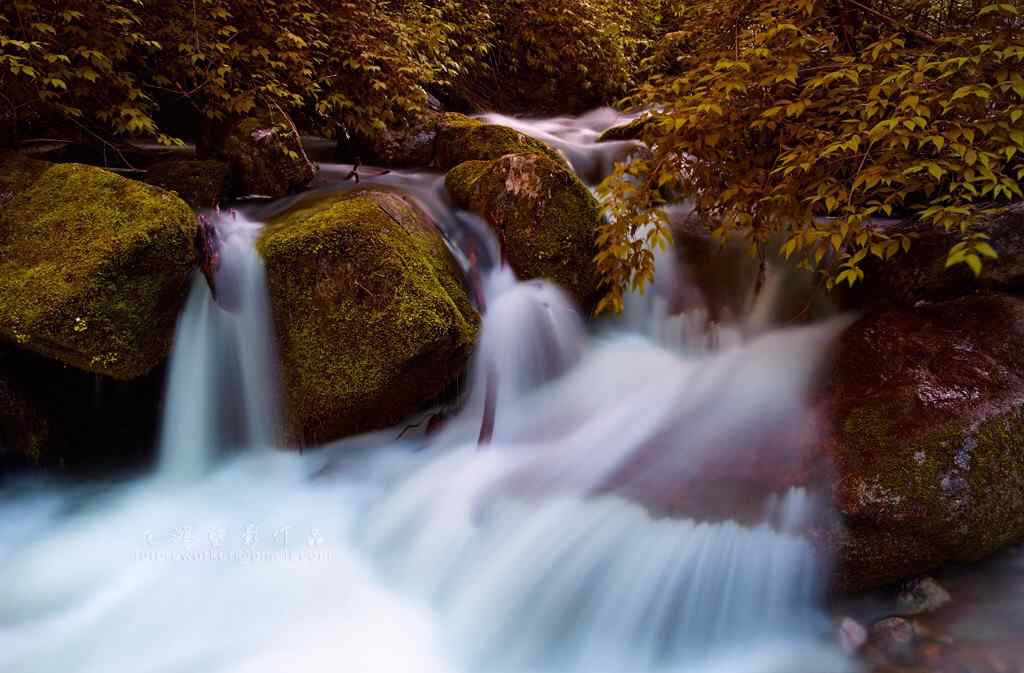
837,405 -> 1024,590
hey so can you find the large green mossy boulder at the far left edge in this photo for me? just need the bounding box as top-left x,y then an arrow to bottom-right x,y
0,154 -> 196,379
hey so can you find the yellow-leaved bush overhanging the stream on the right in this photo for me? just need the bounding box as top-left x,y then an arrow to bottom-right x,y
597,0 -> 1024,309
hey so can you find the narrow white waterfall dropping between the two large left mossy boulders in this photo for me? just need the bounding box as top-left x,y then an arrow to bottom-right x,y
159,213 -> 281,478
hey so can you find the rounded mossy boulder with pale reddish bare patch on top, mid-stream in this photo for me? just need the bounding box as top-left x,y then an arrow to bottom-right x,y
444,154 -> 601,310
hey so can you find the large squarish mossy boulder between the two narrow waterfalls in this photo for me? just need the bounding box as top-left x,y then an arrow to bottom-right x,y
258,186 -> 479,444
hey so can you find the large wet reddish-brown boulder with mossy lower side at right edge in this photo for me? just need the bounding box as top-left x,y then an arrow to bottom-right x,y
826,296 -> 1024,590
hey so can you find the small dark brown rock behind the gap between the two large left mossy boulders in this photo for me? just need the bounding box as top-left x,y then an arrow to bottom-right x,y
202,112 -> 317,198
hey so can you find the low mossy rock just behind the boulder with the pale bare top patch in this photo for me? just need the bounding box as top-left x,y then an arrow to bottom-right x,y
435,113 -> 566,171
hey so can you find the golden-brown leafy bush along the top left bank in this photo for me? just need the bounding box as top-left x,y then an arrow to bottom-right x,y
0,0 -> 487,147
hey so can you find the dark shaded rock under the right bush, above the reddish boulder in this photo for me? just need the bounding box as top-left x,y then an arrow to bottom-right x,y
843,203 -> 1024,308
